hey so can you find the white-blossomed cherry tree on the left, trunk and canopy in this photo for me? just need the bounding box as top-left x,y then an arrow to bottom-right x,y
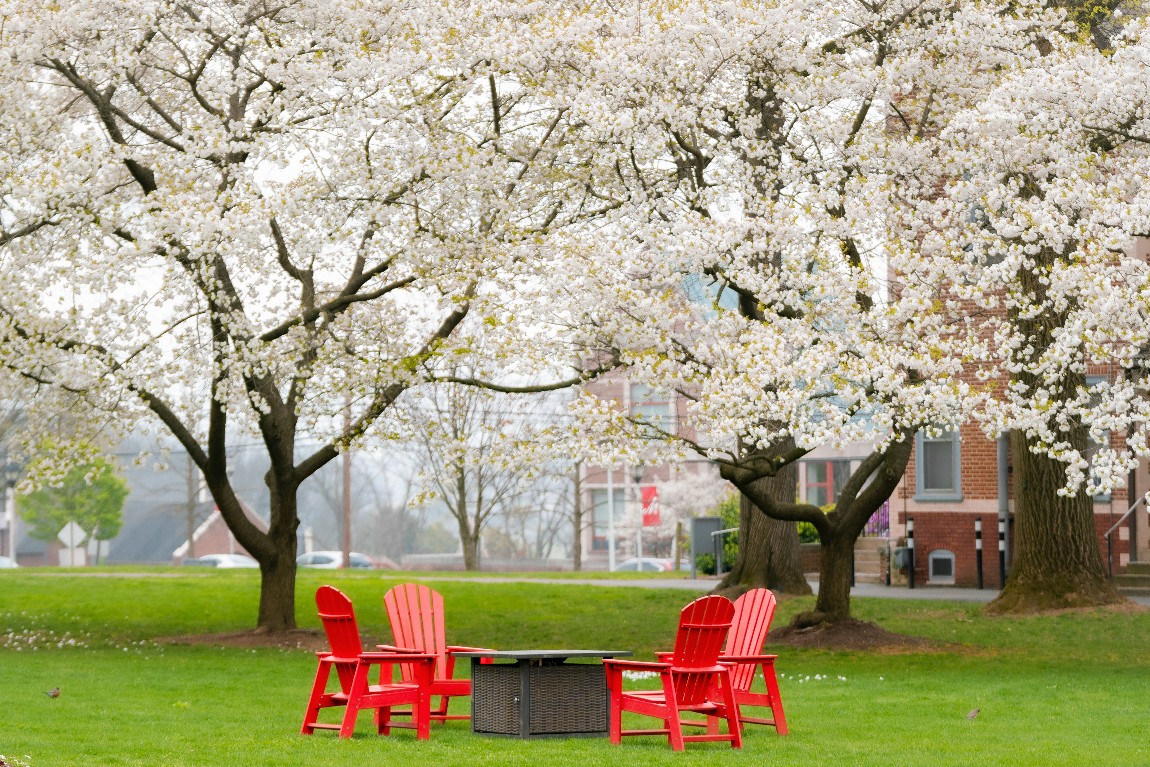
0,0 -> 611,631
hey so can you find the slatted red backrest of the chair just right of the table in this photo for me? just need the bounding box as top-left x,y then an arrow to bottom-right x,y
670,595 -> 735,705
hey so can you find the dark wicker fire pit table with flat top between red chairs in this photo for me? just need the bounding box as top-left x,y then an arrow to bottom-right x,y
452,650 -> 631,738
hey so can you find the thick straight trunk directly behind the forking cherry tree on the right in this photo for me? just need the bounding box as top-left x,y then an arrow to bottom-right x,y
715,463 -> 811,599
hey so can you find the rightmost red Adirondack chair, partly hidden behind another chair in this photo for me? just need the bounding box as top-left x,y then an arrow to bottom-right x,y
711,589 -> 787,735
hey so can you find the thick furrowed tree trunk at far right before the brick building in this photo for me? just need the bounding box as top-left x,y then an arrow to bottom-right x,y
988,429 -> 1122,613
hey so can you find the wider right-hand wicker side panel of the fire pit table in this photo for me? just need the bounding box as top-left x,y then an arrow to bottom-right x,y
529,664 -> 607,735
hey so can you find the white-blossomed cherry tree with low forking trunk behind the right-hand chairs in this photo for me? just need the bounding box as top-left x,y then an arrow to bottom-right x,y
554,1 -> 1060,626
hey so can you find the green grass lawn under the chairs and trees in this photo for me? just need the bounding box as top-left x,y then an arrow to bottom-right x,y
0,569 -> 1150,767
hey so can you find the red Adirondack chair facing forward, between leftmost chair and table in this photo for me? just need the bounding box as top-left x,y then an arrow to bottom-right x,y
377,583 -> 486,722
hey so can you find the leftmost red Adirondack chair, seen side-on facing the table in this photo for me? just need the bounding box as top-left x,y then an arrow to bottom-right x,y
300,585 -> 435,741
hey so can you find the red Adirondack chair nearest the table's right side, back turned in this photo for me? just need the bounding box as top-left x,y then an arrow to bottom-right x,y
603,596 -> 743,751
